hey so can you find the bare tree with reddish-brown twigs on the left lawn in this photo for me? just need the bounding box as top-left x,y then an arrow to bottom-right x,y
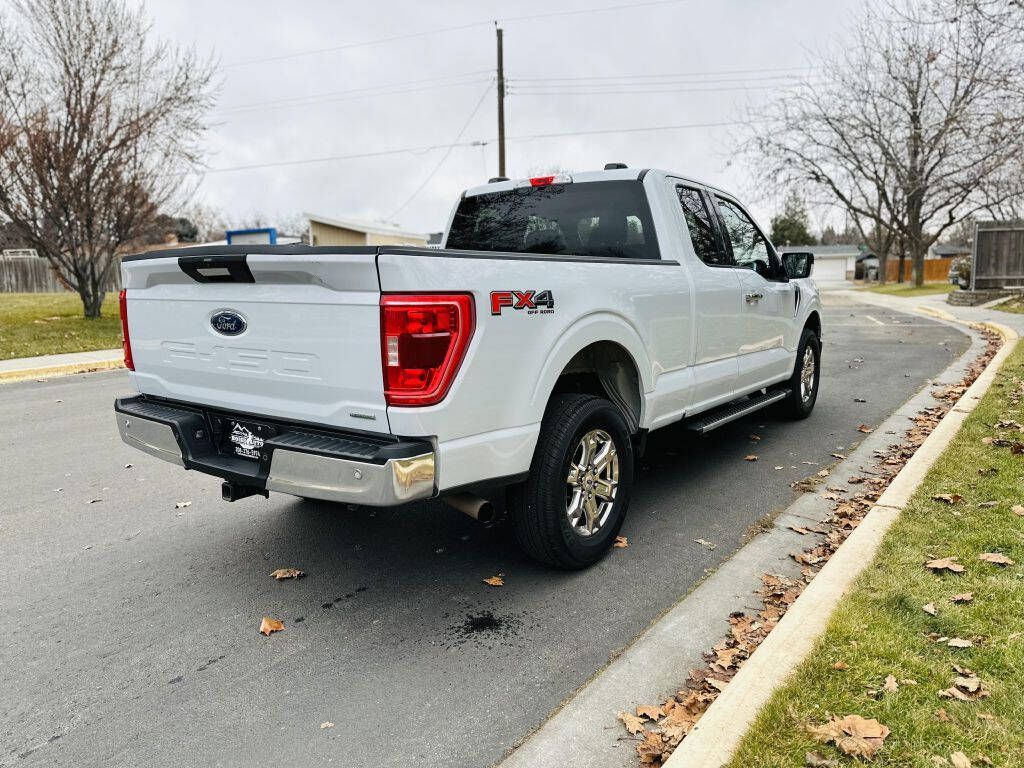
0,0 -> 215,317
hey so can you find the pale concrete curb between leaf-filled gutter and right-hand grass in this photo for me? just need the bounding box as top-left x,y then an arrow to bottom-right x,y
665,319 -> 1018,768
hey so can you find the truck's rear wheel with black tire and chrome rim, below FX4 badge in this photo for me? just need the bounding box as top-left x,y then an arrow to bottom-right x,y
509,394 -> 633,569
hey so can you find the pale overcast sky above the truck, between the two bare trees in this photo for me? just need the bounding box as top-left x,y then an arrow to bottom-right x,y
146,0 -> 861,231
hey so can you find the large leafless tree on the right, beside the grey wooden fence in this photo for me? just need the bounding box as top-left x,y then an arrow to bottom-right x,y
748,0 -> 1024,285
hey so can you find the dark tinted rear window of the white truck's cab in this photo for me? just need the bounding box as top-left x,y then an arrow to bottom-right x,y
447,181 -> 660,259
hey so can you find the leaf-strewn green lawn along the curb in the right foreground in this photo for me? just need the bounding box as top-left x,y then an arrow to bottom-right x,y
730,343 -> 1024,768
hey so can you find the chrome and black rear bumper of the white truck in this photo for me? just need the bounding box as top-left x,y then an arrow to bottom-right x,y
114,397 -> 436,507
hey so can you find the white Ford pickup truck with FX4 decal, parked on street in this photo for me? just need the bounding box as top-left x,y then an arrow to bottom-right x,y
115,164 -> 821,568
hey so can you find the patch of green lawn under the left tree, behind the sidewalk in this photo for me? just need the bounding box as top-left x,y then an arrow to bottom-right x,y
0,292 -> 121,360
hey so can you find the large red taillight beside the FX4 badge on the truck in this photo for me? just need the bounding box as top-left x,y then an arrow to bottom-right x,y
381,293 -> 473,406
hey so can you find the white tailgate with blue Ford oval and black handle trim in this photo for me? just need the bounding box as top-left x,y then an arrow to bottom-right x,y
123,246 -> 388,432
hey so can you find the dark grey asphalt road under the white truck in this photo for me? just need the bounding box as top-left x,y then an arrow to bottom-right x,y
0,295 -> 968,768
